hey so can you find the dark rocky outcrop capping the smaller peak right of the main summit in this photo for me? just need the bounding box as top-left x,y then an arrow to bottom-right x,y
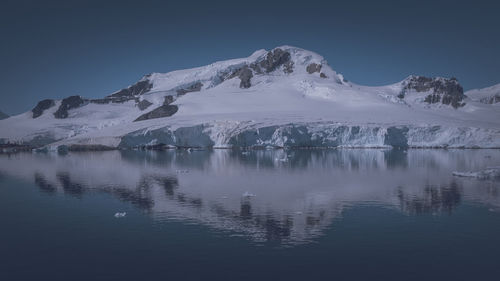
398,76 -> 465,108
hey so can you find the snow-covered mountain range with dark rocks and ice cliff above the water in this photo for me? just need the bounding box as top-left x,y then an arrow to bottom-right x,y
0,46 -> 500,150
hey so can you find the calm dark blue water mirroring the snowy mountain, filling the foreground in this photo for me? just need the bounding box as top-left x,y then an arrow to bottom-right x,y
0,150 -> 500,280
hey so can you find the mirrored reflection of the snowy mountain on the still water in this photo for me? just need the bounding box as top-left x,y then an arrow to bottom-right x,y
0,150 -> 500,244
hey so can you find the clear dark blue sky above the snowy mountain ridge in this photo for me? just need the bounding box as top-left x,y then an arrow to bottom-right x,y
0,0 -> 500,114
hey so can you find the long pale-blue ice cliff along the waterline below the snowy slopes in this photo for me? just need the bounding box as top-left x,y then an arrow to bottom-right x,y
119,122 -> 500,148
